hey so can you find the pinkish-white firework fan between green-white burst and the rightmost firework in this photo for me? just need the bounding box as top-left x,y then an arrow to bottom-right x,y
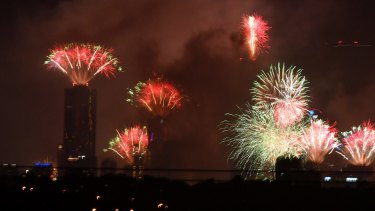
298,120 -> 338,164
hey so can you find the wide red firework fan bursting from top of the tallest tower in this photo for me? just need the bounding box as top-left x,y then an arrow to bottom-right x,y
45,43 -> 122,86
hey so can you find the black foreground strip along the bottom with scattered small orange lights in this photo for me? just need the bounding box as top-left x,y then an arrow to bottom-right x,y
0,175 -> 375,211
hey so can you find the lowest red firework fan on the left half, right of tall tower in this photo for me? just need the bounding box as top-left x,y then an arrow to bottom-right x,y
105,125 -> 148,164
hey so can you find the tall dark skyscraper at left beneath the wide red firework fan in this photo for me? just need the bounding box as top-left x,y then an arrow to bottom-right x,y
58,86 -> 97,176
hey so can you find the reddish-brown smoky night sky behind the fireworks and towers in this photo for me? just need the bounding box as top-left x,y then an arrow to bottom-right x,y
0,0 -> 375,175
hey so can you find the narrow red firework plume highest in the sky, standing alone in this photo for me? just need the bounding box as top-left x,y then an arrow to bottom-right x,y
243,15 -> 270,60
